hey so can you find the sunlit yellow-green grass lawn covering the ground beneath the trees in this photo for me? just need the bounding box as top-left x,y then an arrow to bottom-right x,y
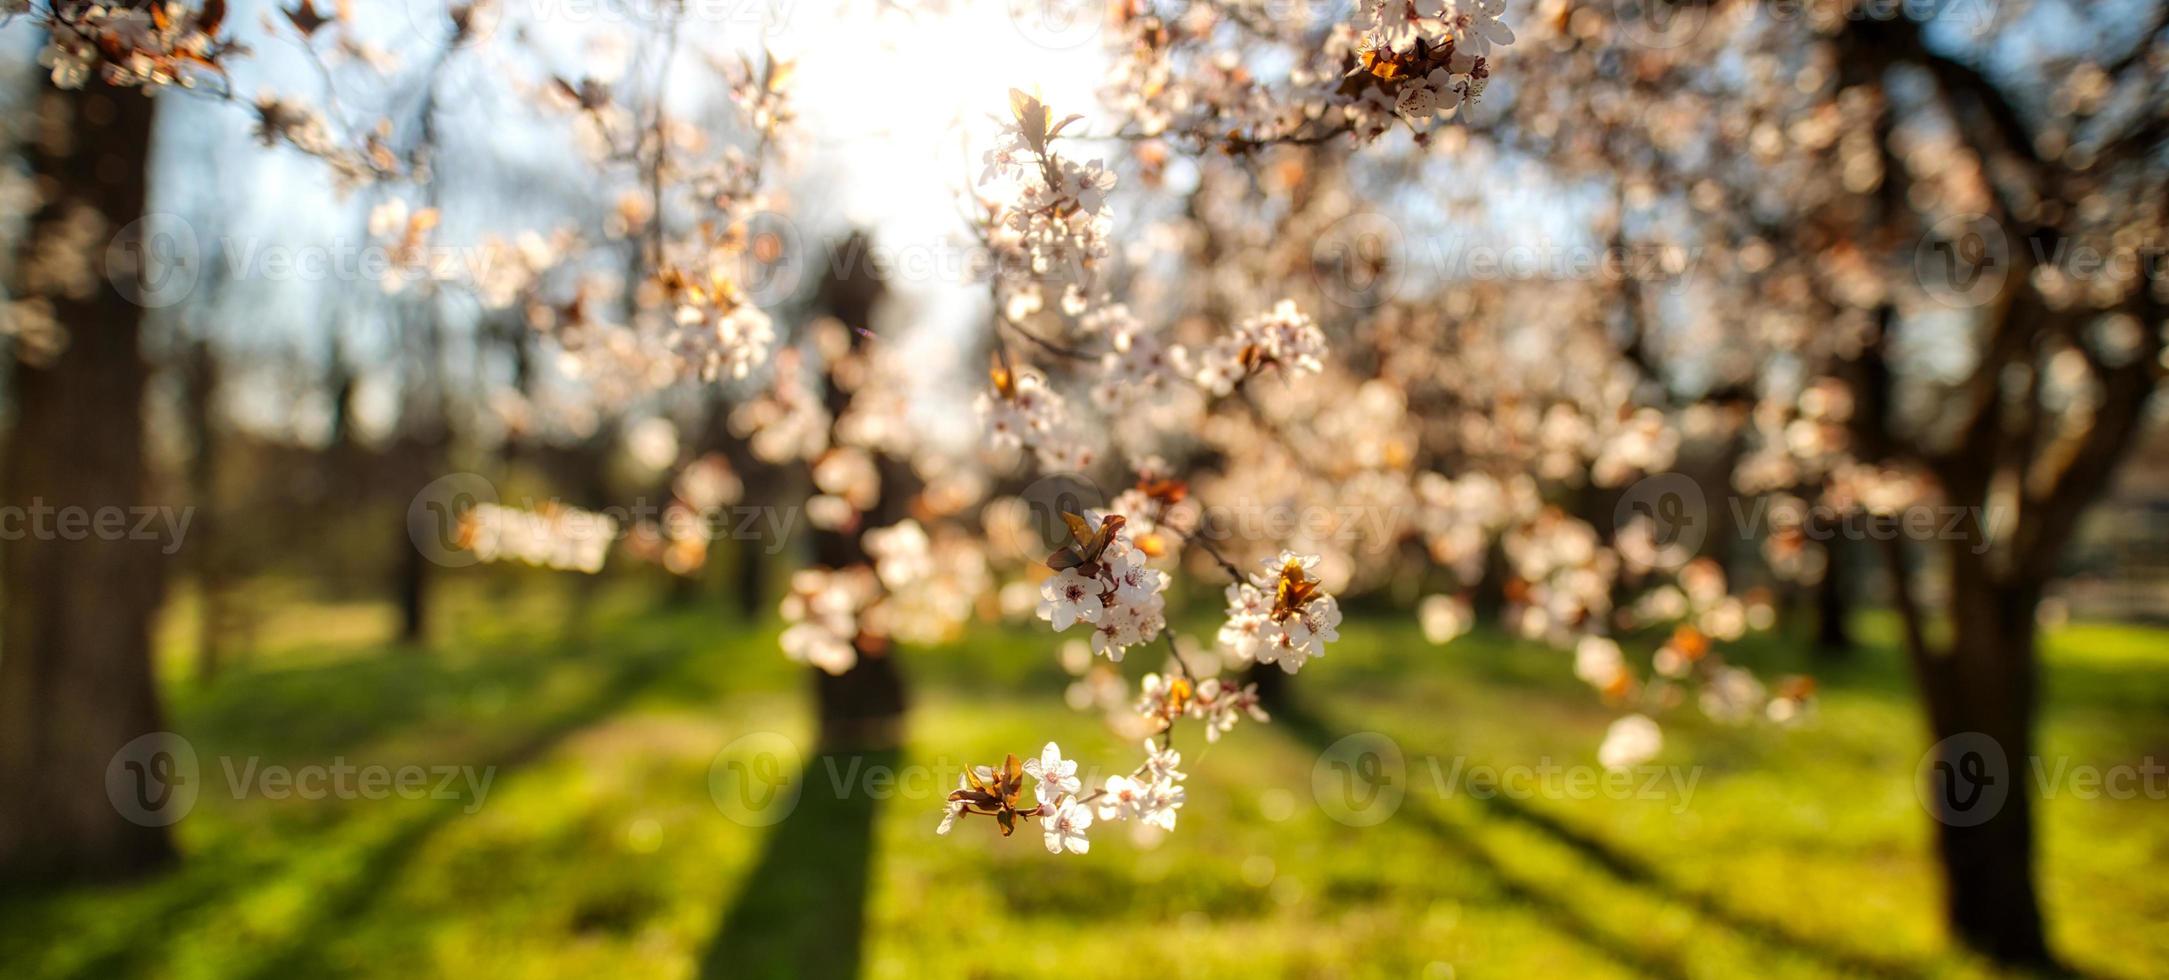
0,579 -> 2169,978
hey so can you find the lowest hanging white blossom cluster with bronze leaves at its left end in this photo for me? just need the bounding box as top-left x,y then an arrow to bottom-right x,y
935,742 -> 1186,854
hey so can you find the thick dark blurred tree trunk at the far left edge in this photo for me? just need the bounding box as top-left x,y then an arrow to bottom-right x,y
0,80 -> 174,882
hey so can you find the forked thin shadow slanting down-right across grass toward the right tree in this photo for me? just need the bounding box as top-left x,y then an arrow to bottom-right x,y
1273,705 -> 1920,978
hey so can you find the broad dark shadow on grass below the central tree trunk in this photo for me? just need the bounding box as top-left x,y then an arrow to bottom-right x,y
701,750 -> 898,978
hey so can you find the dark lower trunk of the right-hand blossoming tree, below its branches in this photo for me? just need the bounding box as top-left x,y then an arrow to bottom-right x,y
1920,546 -> 2054,967
